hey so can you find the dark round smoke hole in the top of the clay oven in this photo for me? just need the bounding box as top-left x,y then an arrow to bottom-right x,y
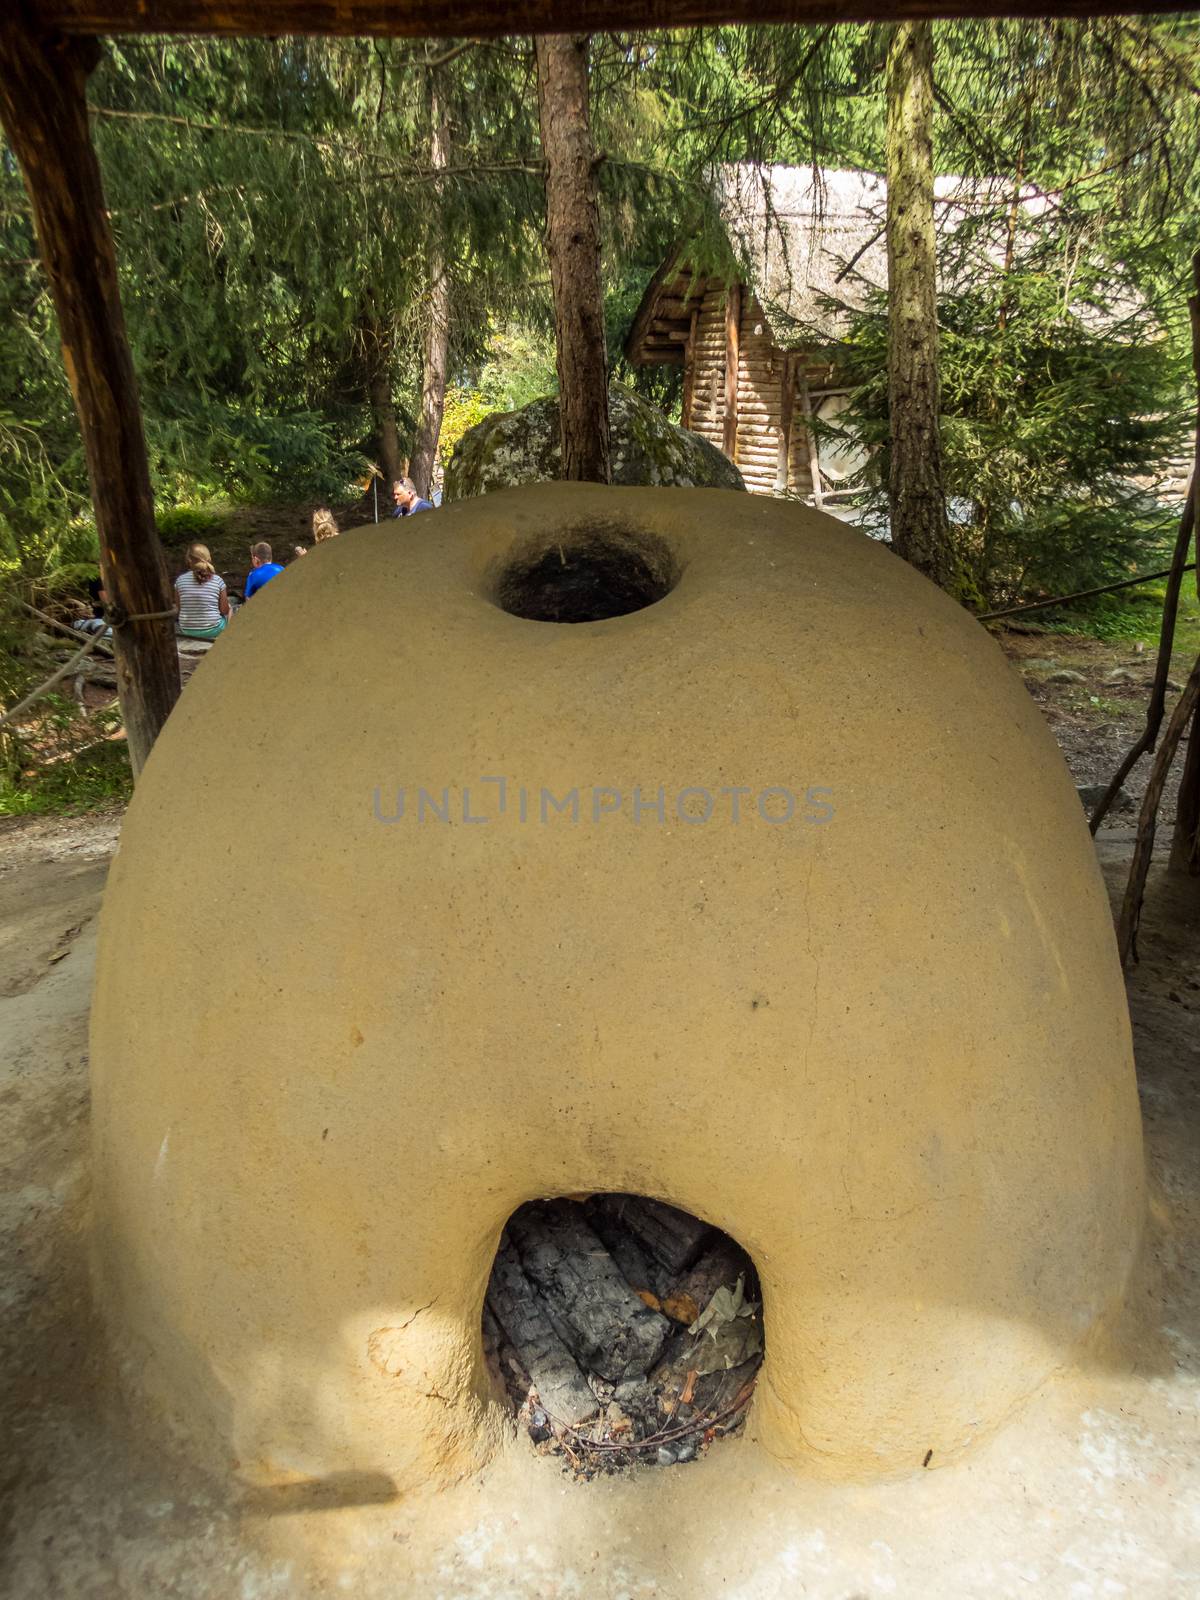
494,520 -> 680,622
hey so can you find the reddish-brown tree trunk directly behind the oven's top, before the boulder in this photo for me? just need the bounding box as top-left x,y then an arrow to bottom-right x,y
536,34 -> 611,483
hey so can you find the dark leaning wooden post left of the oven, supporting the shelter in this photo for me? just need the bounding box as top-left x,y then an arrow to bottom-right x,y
0,18 -> 179,776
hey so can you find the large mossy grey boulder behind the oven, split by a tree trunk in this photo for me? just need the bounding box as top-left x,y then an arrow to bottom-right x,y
443,386 -> 746,501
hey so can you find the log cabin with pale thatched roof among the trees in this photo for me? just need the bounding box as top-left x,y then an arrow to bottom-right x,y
626,165 -> 1117,510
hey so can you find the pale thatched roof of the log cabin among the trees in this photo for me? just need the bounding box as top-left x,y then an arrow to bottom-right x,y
717,163 -> 1081,349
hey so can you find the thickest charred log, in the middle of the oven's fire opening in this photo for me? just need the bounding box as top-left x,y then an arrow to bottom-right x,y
501,1205 -> 670,1384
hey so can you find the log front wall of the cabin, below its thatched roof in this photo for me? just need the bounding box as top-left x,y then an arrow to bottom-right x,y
685,288 -> 829,496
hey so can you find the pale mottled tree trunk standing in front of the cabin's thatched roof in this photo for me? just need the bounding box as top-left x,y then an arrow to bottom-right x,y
886,22 -> 955,587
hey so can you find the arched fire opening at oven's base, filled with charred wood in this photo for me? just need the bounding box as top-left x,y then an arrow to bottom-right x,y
483,1194 -> 763,1478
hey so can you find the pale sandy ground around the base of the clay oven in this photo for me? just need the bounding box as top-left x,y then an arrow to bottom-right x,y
0,816 -> 1200,1600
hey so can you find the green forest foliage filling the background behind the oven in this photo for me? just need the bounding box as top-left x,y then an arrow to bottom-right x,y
0,16 -> 1200,617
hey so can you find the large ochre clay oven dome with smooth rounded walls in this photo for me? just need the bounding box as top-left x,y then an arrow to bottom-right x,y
93,485 -> 1142,1488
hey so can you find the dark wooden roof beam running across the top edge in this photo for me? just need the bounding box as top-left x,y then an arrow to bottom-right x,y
19,0 -> 1194,38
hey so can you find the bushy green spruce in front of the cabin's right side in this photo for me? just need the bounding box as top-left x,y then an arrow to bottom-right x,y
840,243 -> 1187,603
